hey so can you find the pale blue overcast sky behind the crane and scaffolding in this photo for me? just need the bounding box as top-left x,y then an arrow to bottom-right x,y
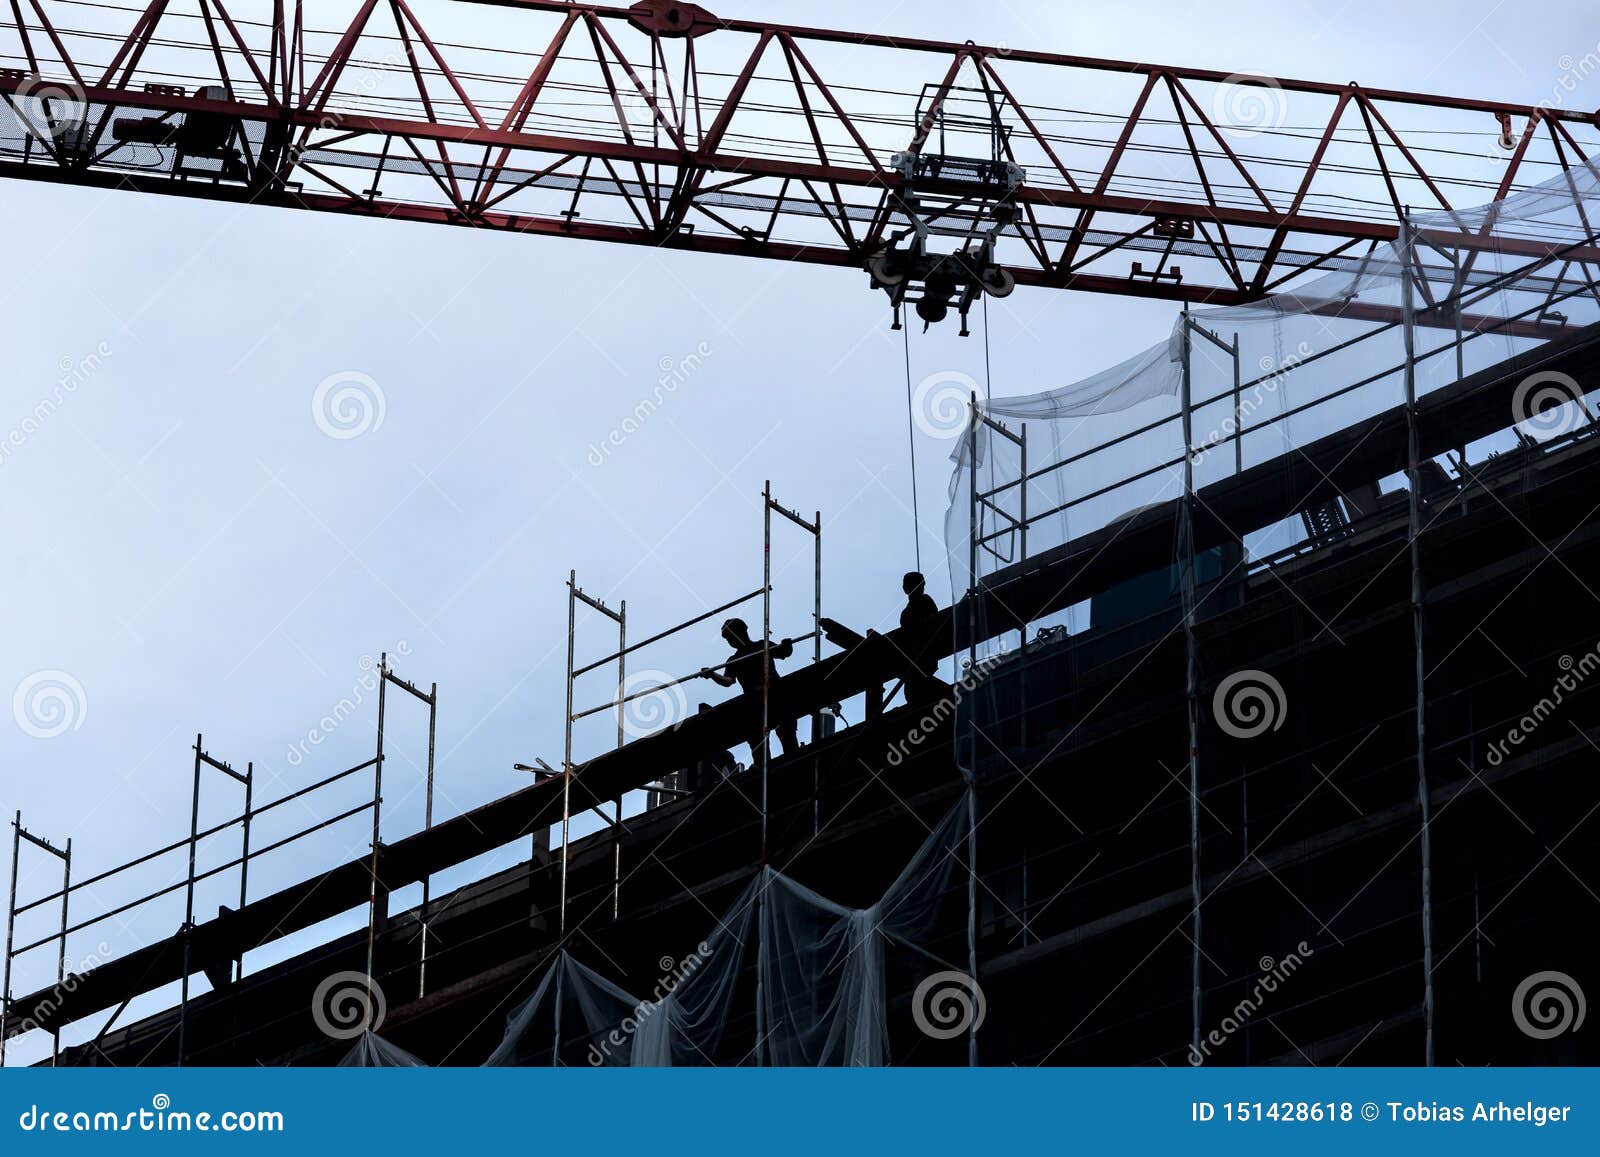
0,0 -> 1600,1059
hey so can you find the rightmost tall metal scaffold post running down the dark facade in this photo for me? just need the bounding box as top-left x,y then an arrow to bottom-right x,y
1398,210 -> 1434,1066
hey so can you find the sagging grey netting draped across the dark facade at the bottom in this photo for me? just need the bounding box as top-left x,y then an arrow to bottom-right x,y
486,802 -> 968,1067
